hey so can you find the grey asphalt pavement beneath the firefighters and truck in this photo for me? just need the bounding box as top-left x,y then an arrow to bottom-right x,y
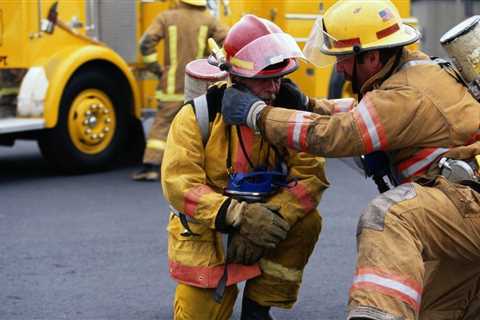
0,142 -> 376,320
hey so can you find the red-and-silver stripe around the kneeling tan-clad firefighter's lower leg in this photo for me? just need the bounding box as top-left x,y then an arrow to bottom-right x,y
350,268 -> 423,310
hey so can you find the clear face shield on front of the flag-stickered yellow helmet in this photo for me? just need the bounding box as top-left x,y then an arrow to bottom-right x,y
303,17 -> 344,68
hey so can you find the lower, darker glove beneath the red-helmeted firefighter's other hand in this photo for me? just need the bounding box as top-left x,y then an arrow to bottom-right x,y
227,231 -> 265,265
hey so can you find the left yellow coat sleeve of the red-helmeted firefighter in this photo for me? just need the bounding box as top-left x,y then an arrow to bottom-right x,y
161,104 -> 228,229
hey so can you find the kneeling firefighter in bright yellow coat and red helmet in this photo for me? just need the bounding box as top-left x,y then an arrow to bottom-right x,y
161,15 -> 328,320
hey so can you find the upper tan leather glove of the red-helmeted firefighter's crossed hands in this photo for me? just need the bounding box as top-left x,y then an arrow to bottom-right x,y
225,199 -> 290,248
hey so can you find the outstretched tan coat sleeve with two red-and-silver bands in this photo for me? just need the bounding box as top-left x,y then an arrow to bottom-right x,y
259,87 -> 438,157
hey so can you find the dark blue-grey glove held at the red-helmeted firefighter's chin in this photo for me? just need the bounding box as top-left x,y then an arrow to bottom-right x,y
222,85 -> 266,130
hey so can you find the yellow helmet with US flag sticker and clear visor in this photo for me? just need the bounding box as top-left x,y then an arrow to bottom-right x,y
304,0 -> 420,65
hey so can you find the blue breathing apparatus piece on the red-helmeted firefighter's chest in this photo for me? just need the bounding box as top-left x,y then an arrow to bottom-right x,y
224,170 -> 288,202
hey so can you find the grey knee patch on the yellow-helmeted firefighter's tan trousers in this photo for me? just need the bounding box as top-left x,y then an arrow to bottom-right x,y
357,183 -> 417,236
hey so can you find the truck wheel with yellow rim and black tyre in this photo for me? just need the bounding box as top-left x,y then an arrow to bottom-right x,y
39,70 -> 128,173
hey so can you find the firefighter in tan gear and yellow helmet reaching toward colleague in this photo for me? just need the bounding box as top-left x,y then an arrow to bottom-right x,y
222,0 -> 480,320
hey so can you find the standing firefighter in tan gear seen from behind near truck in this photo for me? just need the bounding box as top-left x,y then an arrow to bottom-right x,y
132,0 -> 227,181
